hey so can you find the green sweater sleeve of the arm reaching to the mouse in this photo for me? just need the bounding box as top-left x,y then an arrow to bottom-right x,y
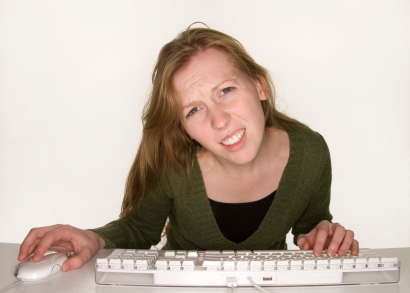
89,176 -> 172,249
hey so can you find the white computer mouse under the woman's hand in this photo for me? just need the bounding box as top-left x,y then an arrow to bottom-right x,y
15,246 -> 71,282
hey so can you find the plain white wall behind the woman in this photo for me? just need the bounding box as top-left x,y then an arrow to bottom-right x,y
0,0 -> 410,248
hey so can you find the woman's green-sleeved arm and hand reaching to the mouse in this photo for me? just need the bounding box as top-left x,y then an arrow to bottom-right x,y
18,175 -> 172,271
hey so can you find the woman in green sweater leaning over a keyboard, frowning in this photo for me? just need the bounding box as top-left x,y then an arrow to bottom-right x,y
18,28 -> 359,271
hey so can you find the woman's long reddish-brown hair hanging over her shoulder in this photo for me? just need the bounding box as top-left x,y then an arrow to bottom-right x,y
120,28 -> 304,218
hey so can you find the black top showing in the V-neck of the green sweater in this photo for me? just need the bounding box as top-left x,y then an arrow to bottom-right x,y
209,190 -> 276,243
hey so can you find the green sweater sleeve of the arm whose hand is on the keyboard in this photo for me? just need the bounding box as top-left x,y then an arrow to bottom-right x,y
292,133 -> 333,245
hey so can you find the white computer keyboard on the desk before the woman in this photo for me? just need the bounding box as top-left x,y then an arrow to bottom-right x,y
95,249 -> 400,287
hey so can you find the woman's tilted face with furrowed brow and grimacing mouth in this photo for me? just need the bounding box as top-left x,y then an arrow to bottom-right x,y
173,48 -> 267,165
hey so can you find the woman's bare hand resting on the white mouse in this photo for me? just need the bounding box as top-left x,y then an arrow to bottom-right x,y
18,225 -> 105,272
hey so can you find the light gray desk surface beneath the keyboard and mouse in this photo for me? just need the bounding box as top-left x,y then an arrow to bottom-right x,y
0,243 -> 410,293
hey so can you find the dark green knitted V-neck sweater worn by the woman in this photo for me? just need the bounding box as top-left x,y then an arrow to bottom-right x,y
91,128 -> 332,250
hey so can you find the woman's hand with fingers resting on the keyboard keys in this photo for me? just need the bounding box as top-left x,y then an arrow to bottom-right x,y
297,220 -> 359,256
